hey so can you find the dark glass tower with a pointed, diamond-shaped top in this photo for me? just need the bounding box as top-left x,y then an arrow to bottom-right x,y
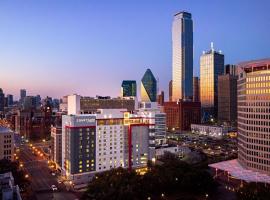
141,69 -> 157,102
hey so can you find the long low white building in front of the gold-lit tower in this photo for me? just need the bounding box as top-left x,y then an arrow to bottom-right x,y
191,124 -> 228,139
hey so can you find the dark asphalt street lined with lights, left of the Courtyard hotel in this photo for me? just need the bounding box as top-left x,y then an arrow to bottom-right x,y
19,145 -> 78,200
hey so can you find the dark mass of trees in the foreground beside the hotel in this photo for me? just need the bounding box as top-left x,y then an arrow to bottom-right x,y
82,154 -> 216,200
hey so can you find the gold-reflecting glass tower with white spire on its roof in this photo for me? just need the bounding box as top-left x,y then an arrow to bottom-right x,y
200,43 -> 224,121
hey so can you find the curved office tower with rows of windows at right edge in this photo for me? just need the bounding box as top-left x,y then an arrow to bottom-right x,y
237,59 -> 270,176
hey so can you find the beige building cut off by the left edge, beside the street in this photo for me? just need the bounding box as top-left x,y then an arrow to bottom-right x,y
0,126 -> 14,160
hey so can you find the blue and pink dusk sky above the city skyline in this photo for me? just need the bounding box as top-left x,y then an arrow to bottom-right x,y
0,0 -> 270,98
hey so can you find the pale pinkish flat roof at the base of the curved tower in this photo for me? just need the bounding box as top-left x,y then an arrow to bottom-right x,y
208,159 -> 270,184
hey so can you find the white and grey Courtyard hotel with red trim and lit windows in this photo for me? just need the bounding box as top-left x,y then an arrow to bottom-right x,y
62,99 -> 165,185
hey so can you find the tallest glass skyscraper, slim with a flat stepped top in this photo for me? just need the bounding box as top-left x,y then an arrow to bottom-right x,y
172,12 -> 193,101
